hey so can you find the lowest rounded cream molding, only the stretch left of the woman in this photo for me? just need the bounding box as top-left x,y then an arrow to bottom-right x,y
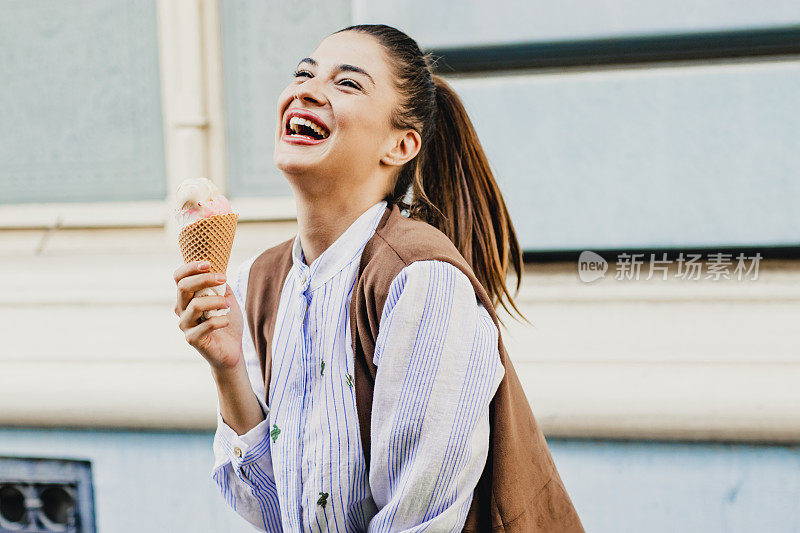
0,360 -> 217,430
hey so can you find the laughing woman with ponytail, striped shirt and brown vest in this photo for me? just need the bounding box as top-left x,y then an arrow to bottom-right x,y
175,25 -> 582,533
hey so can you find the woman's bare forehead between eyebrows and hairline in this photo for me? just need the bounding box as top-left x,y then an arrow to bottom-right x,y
304,31 -> 390,86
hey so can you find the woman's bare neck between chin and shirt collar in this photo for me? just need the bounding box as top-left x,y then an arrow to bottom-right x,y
295,194 -> 381,265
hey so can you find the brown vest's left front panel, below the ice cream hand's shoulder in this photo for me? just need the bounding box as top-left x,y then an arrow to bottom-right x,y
245,237 -> 294,405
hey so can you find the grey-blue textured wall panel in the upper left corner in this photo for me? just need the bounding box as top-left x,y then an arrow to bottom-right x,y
0,0 -> 166,204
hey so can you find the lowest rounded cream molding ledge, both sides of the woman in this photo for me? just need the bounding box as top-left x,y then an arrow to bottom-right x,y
0,361 -> 800,442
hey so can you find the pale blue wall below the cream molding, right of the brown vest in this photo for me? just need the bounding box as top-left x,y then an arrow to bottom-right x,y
551,441 -> 800,533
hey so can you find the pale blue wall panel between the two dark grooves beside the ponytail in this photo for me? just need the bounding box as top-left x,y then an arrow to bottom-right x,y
446,61 -> 800,250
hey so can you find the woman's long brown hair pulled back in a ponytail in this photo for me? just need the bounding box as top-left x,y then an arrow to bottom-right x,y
335,24 -> 525,318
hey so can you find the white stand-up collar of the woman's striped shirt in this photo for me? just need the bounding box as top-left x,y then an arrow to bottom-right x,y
292,200 -> 386,291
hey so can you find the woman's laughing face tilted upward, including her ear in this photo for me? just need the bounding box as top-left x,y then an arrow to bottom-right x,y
273,31 -> 418,194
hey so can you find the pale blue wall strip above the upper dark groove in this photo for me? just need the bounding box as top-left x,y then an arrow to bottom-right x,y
353,0 -> 800,47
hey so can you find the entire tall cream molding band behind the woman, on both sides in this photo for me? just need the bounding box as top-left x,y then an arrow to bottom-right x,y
0,221 -> 800,442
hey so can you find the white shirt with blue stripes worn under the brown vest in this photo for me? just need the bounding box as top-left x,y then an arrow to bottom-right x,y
213,201 -> 504,532
